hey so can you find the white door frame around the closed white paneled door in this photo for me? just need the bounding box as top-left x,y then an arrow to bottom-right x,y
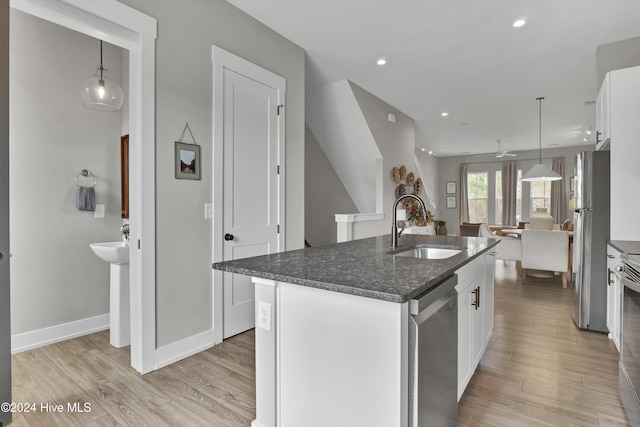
211,45 -> 287,343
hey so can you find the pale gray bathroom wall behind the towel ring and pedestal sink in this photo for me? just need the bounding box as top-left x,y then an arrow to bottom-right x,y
10,9 -> 123,334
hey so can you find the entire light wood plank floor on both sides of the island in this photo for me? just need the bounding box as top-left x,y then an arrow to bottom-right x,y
11,261 -> 628,427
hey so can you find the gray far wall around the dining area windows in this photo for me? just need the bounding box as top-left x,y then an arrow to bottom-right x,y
436,145 -> 595,234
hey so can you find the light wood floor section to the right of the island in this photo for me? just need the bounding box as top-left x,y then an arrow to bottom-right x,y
458,261 -> 628,427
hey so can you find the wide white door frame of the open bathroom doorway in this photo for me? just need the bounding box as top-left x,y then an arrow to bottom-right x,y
10,0 -> 157,374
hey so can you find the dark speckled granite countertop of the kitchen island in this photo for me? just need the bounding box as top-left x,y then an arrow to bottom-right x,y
213,235 -> 499,303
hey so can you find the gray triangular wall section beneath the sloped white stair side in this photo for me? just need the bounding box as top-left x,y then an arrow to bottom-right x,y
304,126 -> 358,246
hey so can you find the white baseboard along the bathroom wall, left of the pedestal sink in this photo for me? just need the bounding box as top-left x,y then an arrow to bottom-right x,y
11,313 -> 109,354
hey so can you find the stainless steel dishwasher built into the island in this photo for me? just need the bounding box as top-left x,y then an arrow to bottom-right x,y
409,274 -> 458,427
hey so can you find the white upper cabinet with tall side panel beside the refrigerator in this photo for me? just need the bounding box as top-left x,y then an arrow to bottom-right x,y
596,66 -> 640,240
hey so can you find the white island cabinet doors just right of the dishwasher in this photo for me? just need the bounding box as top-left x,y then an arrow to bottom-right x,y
456,253 -> 495,400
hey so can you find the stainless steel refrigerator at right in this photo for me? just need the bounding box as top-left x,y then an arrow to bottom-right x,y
571,151 -> 610,332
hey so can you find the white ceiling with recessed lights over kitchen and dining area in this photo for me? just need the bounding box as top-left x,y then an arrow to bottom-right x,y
227,0 -> 640,156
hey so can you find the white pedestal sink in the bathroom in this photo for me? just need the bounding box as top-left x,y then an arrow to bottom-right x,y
89,242 -> 131,348
